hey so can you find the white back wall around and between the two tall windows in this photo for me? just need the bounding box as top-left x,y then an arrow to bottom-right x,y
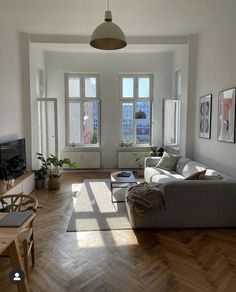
46,52 -> 173,168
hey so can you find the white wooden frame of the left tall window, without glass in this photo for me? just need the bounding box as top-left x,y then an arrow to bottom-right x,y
65,73 -> 101,147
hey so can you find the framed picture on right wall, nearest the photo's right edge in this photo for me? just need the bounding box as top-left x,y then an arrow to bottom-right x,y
217,87 -> 236,143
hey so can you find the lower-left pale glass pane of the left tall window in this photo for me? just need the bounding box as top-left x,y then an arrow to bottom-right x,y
69,102 -> 80,144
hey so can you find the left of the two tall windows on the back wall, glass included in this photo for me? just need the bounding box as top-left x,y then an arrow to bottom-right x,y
65,74 -> 100,146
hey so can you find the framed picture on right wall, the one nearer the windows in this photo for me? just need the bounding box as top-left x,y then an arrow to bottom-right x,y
199,94 -> 212,139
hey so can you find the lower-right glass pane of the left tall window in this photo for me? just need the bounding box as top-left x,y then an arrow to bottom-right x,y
83,101 -> 99,144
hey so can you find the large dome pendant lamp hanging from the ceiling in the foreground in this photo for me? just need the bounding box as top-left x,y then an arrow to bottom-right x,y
90,0 -> 127,50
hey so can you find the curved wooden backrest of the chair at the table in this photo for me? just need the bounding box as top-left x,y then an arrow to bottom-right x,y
0,194 -> 38,213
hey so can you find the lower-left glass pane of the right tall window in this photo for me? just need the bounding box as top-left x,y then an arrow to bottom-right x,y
121,103 -> 134,143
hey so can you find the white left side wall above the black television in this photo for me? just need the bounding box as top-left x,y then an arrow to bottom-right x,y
0,19 -> 23,142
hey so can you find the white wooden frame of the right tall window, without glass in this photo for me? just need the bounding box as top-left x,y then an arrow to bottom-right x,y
119,73 -> 153,147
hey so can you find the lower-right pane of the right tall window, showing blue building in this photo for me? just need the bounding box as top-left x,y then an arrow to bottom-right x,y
135,101 -> 151,144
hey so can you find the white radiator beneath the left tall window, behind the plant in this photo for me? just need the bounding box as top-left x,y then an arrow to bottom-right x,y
61,151 -> 101,169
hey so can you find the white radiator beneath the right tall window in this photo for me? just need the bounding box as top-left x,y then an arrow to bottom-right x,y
117,151 -> 147,169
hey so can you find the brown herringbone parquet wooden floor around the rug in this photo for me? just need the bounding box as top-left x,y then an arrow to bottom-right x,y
0,173 -> 236,292
